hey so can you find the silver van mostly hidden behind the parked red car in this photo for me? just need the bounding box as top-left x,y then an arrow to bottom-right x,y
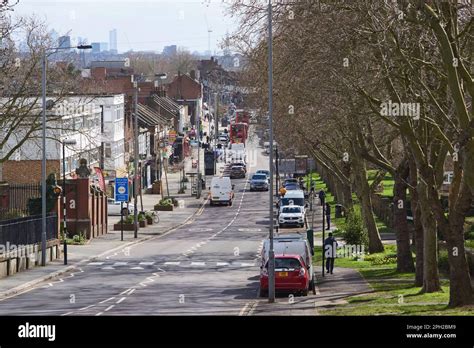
260,233 -> 316,294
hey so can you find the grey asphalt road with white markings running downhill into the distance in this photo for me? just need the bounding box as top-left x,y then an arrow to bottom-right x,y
0,127 -> 316,316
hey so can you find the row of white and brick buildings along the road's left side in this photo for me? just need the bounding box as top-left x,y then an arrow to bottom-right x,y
0,61 -> 215,197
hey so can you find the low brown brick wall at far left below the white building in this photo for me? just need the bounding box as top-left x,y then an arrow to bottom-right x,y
3,160 -> 61,184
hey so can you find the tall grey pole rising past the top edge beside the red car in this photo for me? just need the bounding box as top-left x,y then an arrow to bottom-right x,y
268,0 -> 275,303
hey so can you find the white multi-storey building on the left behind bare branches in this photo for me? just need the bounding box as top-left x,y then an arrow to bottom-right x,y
0,94 -> 125,181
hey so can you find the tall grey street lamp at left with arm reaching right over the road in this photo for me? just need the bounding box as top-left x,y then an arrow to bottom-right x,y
41,45 -> 92,266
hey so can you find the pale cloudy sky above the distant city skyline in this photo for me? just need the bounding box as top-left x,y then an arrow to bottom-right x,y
15,0 -> 236,53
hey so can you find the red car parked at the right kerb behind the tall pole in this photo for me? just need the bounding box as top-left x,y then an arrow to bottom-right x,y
260,254 -> 310,297
